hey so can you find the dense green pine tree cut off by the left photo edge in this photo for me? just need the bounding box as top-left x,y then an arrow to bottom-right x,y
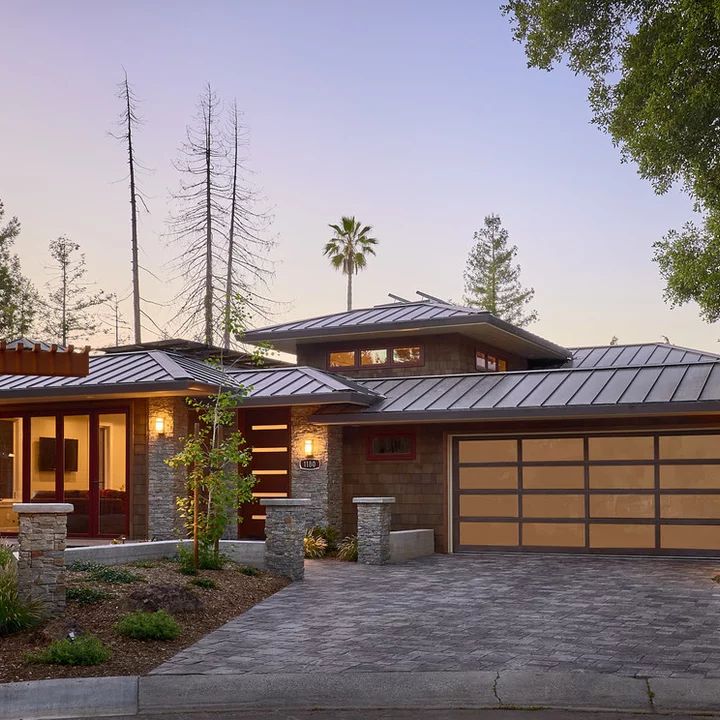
0,200 -> 37,339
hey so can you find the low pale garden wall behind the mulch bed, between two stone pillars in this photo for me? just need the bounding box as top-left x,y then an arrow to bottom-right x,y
65,540 -> 265,569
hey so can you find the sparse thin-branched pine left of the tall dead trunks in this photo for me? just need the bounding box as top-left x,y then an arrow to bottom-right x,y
43,237 -> 107,345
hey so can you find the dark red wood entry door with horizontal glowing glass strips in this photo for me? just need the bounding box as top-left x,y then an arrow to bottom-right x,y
238,408 -> 291,540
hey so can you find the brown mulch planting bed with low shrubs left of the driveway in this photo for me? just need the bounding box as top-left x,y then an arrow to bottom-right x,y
0,560 -> 288,682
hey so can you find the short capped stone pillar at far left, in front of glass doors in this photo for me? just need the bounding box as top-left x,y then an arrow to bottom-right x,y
13,503 -> 73,616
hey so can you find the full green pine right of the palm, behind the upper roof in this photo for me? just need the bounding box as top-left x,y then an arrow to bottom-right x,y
465,215 -> 538,327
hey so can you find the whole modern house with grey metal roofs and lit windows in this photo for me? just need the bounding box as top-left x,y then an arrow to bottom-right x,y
0,296 -> 720,555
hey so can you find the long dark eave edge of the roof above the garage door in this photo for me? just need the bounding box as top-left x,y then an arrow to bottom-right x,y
310,400 -> 720,425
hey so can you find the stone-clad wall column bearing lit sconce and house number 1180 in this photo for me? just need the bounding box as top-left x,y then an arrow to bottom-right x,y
290,405 -> 343,532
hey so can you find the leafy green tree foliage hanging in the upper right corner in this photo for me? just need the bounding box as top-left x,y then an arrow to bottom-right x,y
503,0 -> 720,320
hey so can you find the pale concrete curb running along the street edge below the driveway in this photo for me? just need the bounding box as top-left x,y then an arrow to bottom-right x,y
0,670 -> 720,720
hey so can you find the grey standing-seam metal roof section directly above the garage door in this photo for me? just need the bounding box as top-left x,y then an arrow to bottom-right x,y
315,361 -> 720,423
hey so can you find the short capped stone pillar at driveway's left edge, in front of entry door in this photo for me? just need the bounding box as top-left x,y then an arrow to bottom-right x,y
260,498 -> 310,580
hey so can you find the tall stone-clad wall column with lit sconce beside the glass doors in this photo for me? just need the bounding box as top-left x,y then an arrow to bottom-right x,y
148,397 -> 189,540
